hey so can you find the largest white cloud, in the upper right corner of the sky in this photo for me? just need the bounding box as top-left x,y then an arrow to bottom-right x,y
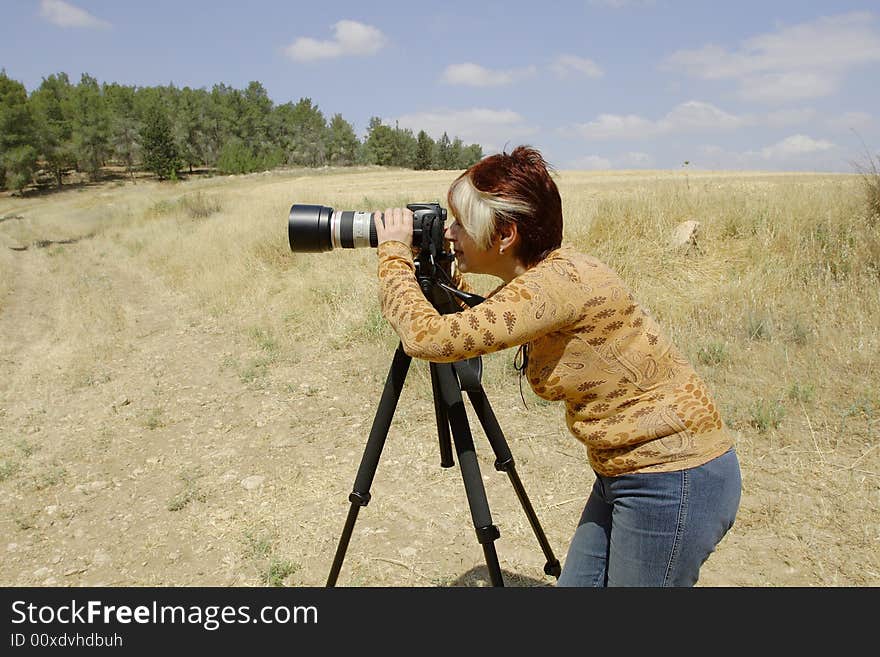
663,12 -> 880,103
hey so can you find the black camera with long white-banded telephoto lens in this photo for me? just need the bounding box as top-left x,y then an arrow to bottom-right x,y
287,203 -> 446,255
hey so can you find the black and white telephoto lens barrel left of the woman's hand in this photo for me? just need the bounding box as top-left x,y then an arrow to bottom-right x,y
287,204 -> 381,253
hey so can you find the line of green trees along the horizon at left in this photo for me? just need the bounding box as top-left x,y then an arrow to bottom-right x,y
0,70 -> 483,191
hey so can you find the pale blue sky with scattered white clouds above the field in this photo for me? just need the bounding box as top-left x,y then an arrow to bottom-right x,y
0,0 -> 880,172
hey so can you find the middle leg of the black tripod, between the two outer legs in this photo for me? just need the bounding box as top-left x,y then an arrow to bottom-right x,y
431,363 -> 504,586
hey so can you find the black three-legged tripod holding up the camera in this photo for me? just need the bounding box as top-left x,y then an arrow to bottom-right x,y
327,255 -> 561,587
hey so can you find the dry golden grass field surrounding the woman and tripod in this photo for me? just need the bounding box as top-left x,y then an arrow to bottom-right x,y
0,169 -> 880,587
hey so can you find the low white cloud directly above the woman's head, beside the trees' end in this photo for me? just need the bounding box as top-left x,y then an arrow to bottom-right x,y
388,107 -> 537,153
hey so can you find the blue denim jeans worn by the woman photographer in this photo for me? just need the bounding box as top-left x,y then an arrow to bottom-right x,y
557,448 -> 742,587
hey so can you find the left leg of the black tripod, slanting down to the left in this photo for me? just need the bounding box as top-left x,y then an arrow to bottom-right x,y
327,345 -> 412,586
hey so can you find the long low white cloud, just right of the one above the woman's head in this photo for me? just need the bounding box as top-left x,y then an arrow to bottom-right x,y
574,100 -> 754,139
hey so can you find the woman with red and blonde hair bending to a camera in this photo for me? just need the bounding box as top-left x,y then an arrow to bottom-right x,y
376,146 -> 741,586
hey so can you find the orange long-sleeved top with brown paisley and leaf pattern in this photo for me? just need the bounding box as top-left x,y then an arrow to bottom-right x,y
378,241 -> 733,476
